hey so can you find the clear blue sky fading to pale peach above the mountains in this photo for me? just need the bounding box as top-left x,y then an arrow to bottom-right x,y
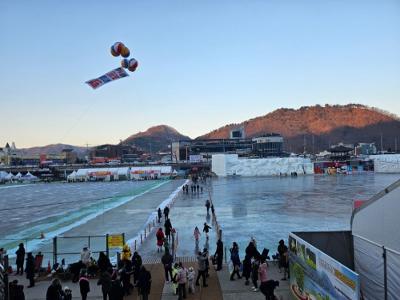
0,0 -> 400,147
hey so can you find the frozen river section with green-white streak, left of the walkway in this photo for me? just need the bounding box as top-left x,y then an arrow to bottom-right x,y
0,180 -> 184,262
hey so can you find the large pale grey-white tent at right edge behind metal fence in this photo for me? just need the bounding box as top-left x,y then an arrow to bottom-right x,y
351,180 -> 400,300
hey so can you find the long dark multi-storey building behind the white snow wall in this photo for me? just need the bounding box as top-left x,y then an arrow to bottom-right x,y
171,133 -> 284,162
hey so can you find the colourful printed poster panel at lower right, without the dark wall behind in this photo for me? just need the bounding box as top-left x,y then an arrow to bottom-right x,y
289,233 -> 360,300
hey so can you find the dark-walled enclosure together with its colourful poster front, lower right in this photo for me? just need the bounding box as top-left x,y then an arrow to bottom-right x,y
289,231 -> 360,300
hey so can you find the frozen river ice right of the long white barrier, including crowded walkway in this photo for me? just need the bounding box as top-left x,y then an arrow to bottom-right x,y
138,173 -> 400,256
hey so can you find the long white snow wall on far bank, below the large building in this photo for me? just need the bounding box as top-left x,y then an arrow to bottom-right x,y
212,154 -> 314,176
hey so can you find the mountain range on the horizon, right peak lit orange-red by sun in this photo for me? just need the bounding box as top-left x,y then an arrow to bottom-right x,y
14,104 -> 400,153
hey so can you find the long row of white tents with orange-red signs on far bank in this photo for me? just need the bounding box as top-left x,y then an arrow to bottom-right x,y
67,166 -> 178,182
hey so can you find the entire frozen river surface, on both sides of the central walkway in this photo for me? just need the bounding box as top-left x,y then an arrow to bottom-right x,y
0,173 -> 400,257
